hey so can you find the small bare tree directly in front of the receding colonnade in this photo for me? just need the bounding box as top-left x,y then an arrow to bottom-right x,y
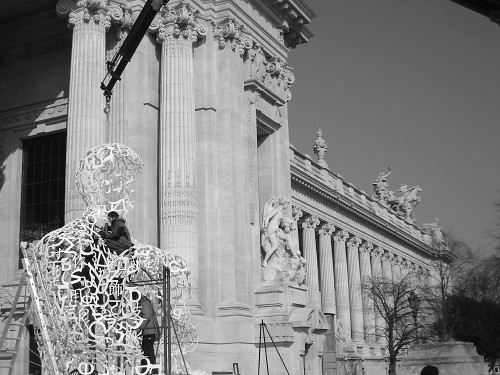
363,274 -> 418,375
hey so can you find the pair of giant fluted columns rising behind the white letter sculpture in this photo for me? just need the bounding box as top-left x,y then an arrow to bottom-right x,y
56,0 -> 207,310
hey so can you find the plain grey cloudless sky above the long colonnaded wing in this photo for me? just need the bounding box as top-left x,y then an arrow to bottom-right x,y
288,0 -> 500,252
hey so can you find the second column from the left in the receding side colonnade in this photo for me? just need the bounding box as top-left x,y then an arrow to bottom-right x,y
319,223 -> 336,315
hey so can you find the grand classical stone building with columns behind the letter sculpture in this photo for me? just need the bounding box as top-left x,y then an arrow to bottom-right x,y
0,0 -> 444,374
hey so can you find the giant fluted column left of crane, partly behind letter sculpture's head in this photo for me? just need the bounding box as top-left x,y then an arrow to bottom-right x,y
56,0 -> 111,222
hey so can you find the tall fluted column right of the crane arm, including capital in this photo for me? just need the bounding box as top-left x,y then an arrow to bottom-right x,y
150,5 -> 207,313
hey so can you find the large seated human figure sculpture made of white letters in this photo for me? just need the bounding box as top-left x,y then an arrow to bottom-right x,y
22,144 -> 197,375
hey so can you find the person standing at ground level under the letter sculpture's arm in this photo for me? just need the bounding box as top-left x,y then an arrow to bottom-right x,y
137,295 -> 160,374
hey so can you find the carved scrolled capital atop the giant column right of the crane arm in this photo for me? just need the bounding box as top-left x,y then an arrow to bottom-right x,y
149,4 -> 208,43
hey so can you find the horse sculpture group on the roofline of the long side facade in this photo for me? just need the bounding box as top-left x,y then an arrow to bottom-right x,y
372,167 -> 423,224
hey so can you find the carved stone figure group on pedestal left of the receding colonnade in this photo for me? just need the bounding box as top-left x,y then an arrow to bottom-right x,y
261,197 -> 306,285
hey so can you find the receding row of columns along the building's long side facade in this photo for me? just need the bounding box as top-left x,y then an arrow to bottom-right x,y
294,210 -> 423,342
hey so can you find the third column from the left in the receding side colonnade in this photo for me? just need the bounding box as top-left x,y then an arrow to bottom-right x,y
333,229 -> 352,340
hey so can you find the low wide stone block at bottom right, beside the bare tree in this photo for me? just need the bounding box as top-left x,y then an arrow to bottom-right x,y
398,341 -> 488,375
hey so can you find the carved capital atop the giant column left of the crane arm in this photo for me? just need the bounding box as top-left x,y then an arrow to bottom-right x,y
56,0 -> 111,30
